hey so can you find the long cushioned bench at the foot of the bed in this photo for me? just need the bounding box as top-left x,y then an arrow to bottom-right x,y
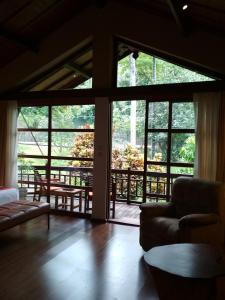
0,200 -> 50,231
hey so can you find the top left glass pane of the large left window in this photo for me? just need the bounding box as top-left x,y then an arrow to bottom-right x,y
18,106 -> 48,129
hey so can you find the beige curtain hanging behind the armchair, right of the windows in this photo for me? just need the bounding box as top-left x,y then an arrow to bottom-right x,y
194,93 -> 221,181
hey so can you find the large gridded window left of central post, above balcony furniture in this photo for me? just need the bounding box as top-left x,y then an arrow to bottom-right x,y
18,105 -> 95,195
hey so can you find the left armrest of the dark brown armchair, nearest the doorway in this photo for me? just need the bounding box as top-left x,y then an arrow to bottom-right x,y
140,202 -> 175,218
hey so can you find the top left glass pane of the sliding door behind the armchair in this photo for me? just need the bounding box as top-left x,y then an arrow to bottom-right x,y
148,102 -> 169,129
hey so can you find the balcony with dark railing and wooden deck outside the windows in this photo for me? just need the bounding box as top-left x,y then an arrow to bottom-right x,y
18,166 -> 191,224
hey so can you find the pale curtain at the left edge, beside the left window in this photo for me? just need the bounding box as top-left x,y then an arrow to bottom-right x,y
5,101 -> 18,187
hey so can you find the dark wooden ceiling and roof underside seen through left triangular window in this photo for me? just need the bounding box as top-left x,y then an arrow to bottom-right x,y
0,0 -> 225,90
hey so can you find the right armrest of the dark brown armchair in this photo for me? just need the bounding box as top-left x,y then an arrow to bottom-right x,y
179,213 -> 219,228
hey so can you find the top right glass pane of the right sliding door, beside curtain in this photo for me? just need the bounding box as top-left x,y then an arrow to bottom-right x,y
172,102 -> 195,129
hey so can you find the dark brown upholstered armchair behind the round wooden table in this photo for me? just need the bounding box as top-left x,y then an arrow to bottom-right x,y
140,177 -> 225,251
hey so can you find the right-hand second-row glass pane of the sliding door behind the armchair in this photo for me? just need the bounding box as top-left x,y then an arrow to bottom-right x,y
171,133 -> 195,163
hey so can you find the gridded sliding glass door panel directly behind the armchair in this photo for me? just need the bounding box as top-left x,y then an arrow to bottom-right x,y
145,101 -> 195,201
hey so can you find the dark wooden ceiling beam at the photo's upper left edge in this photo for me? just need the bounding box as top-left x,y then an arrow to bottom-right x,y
0,27 -> 39,53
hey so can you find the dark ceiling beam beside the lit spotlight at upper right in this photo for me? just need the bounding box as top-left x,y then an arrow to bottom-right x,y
167,0 -> 189,35
